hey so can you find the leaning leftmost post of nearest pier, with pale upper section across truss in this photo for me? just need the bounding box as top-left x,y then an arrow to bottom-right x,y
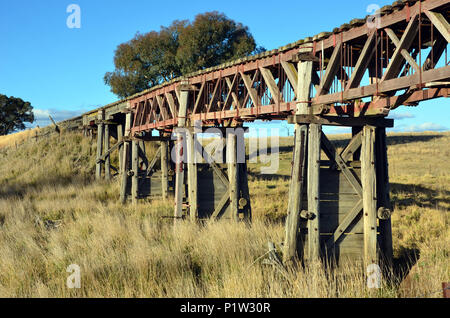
283,48 -> 313,265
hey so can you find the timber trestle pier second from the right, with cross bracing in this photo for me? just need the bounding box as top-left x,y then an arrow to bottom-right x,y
174,127 -> 251,221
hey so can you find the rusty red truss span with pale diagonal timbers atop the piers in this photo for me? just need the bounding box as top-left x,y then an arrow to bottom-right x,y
128,0 -> 450,134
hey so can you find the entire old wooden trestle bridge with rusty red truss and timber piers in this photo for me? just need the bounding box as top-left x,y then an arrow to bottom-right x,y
62,0 -> 450,264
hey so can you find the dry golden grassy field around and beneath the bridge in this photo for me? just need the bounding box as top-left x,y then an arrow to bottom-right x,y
0,128 -> 450,297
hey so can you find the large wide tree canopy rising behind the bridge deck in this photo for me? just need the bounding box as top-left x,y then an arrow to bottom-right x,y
104,11 -> 264,98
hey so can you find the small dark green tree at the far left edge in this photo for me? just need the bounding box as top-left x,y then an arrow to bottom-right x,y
0,94 -> 34,135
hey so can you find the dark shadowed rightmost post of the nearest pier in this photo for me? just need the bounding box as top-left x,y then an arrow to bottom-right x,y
376,127 -> 393,269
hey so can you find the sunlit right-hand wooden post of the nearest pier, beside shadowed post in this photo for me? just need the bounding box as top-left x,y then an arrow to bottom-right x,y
361,126 -> 378,267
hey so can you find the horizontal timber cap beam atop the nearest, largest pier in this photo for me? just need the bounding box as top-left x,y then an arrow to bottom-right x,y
288,115 -> 394,128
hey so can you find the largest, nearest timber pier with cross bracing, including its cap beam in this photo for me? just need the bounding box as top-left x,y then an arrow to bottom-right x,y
285,115 -> 393,265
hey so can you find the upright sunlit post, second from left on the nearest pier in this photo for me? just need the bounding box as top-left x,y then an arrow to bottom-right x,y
307,124 -> 322,262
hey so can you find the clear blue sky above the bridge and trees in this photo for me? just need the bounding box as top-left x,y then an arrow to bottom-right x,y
0,0 -> 450,132
